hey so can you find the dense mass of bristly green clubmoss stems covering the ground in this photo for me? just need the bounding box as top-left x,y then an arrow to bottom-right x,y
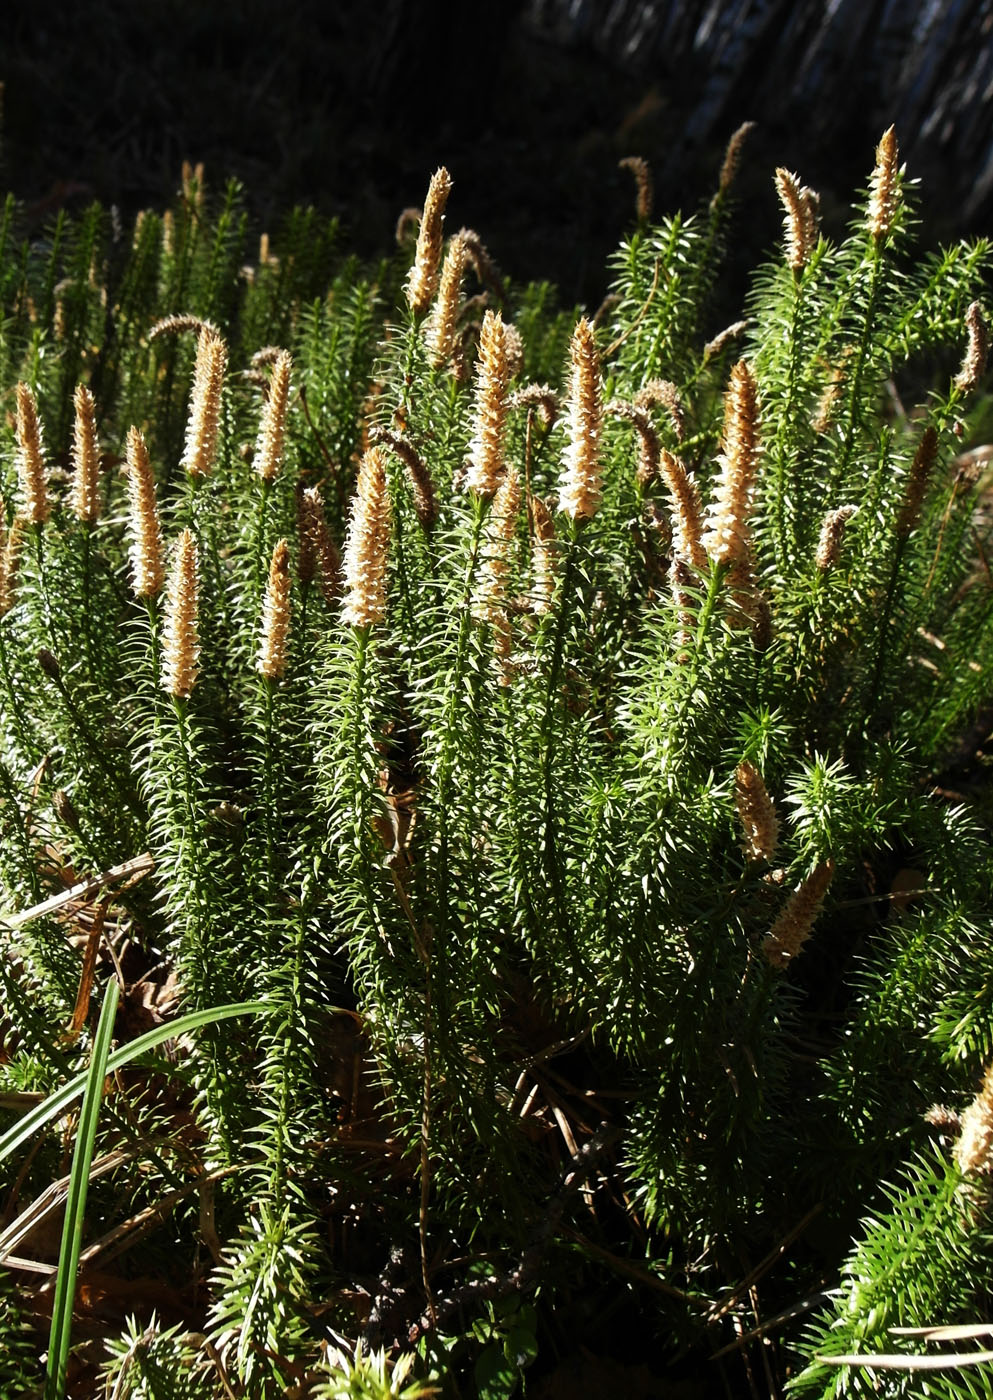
0,133 -> 993,1400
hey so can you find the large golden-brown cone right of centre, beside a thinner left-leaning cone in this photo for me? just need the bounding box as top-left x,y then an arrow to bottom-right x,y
703,360 -> 759,564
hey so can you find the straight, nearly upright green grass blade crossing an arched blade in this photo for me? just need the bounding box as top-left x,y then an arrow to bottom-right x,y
45,980 -> 119,1400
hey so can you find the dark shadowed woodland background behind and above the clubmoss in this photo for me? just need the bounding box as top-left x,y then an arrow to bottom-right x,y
0,0 -> 993,301
